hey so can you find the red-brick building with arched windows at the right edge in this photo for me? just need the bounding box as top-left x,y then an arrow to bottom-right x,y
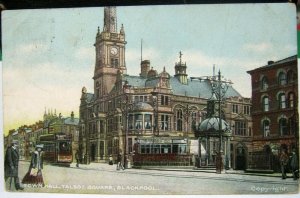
248,56 -> 299,170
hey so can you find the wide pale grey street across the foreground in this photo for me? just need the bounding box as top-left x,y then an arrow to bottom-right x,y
5,161 -> 299,195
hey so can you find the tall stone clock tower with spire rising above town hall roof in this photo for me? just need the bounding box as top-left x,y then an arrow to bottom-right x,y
93,7 -> 126,98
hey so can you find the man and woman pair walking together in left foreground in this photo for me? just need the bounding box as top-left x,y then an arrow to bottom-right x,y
4,141 -> 45,191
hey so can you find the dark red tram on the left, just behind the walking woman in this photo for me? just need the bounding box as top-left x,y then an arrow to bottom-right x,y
39,133 -> 73,166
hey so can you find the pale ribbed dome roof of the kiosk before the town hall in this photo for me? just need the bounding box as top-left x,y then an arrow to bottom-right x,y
199,117 -> 229,132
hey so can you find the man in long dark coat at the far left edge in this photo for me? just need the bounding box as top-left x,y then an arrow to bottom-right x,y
4,141 -> 24,190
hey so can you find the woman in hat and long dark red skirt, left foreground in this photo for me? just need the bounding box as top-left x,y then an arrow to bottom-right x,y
22,144 -> 45,187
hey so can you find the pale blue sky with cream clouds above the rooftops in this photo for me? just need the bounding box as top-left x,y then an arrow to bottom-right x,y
2,4 -> 297,136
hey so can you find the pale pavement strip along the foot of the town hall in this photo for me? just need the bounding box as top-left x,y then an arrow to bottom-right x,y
70,163 -> 292,178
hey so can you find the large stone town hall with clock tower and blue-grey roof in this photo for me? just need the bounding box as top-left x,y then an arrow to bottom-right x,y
79,7 -> 252,169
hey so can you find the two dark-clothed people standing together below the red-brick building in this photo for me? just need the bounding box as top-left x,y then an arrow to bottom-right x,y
279,150 -> 299,180
